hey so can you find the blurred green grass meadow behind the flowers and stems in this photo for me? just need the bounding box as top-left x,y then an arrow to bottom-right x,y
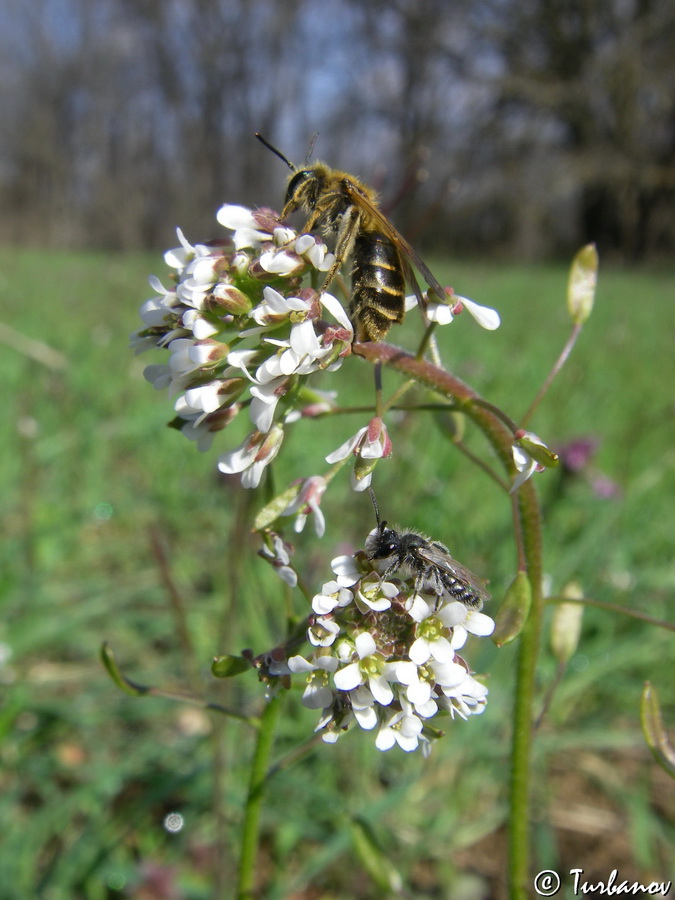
0,250 -> 675,900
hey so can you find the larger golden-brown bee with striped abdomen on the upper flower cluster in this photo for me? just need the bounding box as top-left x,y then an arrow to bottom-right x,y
256,133 -> 445,341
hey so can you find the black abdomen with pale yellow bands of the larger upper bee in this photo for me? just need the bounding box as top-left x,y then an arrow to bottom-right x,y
349,231 -> 405,341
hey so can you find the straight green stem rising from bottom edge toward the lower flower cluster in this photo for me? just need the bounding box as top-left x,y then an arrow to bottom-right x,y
237,697 -> 281,900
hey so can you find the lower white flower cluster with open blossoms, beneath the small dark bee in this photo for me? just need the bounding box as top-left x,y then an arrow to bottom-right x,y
288,536 -> 494,752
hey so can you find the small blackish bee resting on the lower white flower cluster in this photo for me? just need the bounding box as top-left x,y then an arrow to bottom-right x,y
366,493 -> 490,610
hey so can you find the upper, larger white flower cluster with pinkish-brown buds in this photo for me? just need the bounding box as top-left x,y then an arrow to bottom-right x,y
133,205 -> 354,488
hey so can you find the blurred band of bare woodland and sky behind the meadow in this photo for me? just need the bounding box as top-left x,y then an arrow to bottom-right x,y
0,0 -> 675,259
